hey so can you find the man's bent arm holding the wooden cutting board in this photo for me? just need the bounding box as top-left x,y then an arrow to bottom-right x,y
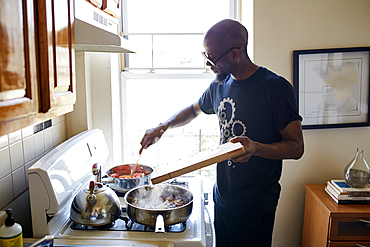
230,120 -> 304,162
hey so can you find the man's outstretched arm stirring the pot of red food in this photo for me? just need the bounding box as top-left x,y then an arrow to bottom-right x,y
139,102 -> 201,154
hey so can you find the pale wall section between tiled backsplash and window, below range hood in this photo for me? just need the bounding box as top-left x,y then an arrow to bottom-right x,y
67,52 -> 123,168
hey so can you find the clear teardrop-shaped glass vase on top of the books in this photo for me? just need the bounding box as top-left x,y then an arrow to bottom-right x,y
344,149 -> 370,188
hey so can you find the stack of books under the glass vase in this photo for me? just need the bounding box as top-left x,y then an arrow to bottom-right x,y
325,180 -> 370,204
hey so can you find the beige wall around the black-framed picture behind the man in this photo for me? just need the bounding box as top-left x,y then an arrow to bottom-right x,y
246,0 -> 370,247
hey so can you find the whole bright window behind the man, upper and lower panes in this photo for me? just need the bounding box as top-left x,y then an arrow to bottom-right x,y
122,0 -> 243,192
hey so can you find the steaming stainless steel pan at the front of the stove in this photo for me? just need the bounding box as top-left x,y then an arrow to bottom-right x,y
124,184 -> 193,232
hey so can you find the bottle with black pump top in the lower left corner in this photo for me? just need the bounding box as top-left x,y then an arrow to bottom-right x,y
0,208 -> 23,247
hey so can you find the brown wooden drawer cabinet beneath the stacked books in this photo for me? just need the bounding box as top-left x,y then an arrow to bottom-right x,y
302,184 -> 370,247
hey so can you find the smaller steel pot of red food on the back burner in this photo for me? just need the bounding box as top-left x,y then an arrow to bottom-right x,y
103,164 -> 153,193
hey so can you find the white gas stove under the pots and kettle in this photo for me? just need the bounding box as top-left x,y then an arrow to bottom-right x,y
28,129 -> 209,247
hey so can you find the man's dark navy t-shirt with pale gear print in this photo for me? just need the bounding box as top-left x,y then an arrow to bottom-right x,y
199,67 -> 302,214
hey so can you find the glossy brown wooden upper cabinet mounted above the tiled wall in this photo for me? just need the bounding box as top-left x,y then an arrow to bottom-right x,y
0,0 -> 76,136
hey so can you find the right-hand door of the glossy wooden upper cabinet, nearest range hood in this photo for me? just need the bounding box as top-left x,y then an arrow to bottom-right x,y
37,0 -> 76,113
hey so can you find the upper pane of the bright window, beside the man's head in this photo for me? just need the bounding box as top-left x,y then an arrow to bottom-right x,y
122,0 -> 235,73
